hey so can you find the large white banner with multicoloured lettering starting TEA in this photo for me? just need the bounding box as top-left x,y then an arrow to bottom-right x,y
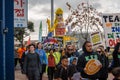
102,13 -> 120,47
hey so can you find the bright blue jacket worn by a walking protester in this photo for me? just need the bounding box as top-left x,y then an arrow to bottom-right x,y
35,49 -> 48,64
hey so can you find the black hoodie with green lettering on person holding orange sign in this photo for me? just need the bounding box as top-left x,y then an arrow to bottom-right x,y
77,52 -> 101,79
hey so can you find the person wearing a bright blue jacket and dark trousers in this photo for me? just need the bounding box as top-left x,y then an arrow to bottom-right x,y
35,42 -> 48,80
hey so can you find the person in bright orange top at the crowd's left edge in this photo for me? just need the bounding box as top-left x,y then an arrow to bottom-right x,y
17,45 -> 26,73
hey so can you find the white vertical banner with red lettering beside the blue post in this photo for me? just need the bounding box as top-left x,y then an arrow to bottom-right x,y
14,0 -> 28,28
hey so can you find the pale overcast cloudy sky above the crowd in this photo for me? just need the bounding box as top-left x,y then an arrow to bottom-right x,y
25,0 -> 120,40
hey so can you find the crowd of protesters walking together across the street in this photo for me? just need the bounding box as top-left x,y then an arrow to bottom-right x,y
15,41 -> 120,80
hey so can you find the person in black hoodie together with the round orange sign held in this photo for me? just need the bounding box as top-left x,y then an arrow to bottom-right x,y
77,41 -> 102,80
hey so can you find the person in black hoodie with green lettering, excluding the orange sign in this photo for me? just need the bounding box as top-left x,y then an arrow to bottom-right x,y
77,41 -> 102,80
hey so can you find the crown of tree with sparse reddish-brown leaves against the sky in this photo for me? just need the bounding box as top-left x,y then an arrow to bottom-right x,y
65,2 -> 103,39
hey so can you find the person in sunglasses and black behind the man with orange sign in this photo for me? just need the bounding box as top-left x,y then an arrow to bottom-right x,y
96,46 -> 109,80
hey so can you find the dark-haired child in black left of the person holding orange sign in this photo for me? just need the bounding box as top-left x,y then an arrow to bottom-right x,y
55,56 -> 69,80
